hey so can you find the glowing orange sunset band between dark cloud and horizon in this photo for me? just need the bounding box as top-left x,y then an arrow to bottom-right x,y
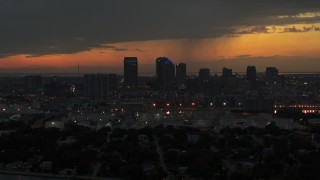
0,25 -> 320,73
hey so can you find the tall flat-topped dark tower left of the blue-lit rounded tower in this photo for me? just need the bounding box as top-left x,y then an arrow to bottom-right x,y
123,57 -> 138,87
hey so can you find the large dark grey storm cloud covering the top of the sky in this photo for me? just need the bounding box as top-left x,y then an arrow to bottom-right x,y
0,0 -> 320,57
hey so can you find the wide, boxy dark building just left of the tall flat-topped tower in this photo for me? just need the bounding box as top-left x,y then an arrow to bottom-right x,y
84,74 -> 117,98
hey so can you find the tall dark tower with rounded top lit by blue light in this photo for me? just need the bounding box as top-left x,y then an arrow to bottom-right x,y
156,57 -> 175,90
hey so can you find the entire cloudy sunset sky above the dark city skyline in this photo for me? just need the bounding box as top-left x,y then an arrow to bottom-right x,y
0,0 -> 320,74
